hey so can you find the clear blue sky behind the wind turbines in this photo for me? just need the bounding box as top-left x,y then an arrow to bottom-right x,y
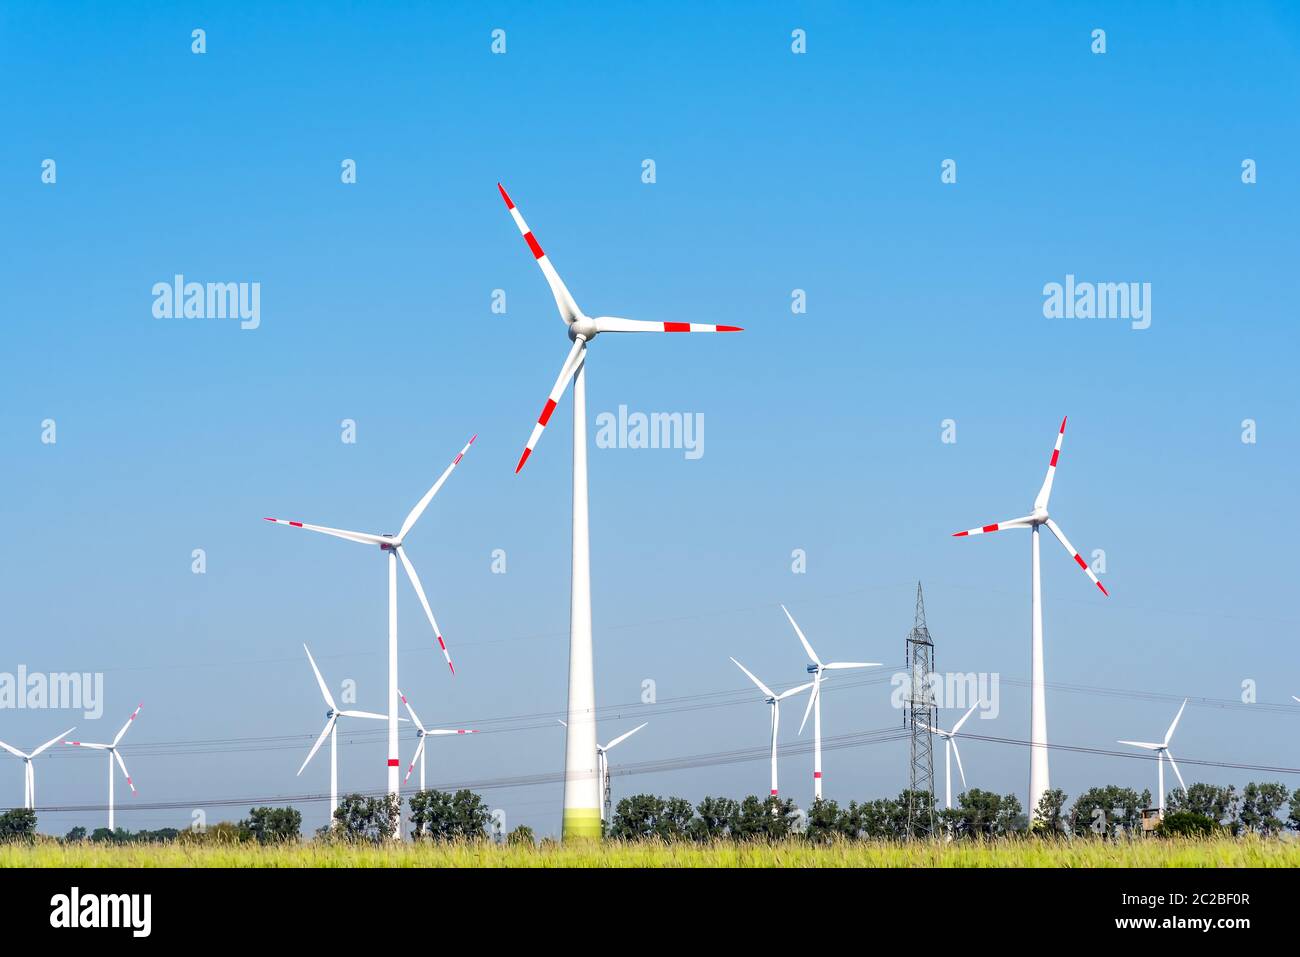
0,3 -> 1300,832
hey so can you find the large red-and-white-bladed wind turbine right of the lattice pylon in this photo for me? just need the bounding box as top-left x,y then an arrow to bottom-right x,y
953,416 -> 1110,820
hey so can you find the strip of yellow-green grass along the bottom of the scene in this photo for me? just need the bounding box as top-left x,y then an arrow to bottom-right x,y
0,837 -> 1300,867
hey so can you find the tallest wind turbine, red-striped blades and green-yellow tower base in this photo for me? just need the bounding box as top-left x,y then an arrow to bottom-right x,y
497,183 -> 741,837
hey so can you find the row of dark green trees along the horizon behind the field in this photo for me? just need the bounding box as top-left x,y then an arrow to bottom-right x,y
0,781 -> 1300,844
